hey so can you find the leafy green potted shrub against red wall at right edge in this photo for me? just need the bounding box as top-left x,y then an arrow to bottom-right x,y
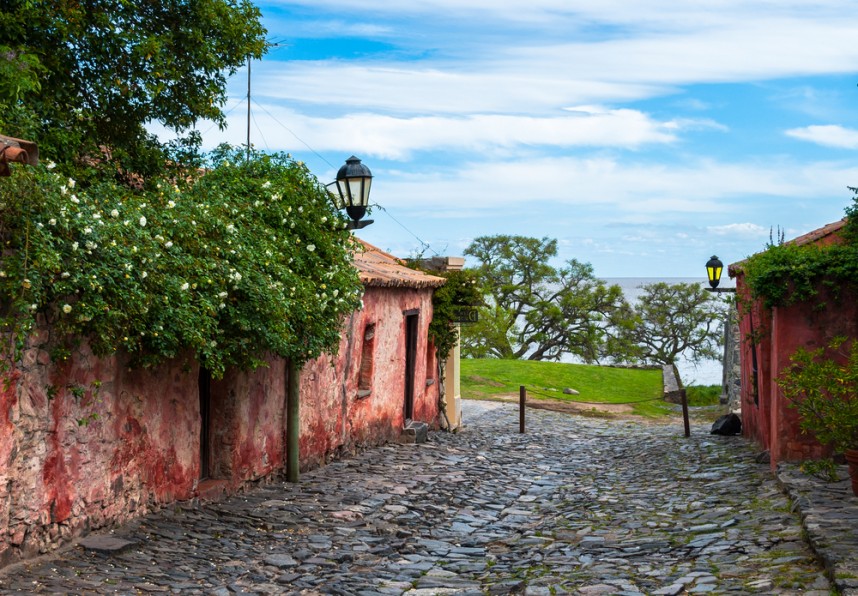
776,337 -> 858,451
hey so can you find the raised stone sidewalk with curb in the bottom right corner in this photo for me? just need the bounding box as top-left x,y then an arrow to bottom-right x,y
775,463 -> 858,596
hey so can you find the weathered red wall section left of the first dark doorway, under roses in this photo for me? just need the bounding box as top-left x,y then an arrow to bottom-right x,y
0,338 -> 199,562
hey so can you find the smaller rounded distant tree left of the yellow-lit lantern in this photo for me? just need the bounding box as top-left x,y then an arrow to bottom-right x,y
624,282 -> 724,364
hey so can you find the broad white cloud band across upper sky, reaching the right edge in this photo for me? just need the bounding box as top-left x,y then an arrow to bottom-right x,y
247,14 -> 858,120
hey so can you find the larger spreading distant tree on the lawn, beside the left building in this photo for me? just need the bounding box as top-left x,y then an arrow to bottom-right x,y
462,235 -> 630,362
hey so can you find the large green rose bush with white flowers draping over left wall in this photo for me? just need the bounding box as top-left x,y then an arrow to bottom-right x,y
0,148 -> 362,376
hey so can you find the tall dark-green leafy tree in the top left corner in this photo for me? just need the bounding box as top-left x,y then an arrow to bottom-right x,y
0,0 -> 266,179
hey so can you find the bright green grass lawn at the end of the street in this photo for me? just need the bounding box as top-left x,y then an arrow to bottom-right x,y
461,358 -> 675,417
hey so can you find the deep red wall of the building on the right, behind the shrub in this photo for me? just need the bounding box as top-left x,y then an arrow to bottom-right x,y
736,273 -> 858,468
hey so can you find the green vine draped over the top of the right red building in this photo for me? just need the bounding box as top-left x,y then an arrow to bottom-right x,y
742,189 -> 858,308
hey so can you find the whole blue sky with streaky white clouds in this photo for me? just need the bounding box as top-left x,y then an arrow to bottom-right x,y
194,0 -> 858,277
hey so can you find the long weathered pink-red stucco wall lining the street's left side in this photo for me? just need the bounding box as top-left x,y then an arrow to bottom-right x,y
0,288 -> 438,565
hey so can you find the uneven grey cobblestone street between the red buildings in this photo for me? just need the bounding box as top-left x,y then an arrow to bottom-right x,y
0,405 -> 830,596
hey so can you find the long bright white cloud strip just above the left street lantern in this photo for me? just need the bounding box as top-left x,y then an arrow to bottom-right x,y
194,105 -> 684,160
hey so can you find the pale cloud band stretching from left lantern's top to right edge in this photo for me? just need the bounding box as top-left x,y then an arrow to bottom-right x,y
373,157 -> 858,214
